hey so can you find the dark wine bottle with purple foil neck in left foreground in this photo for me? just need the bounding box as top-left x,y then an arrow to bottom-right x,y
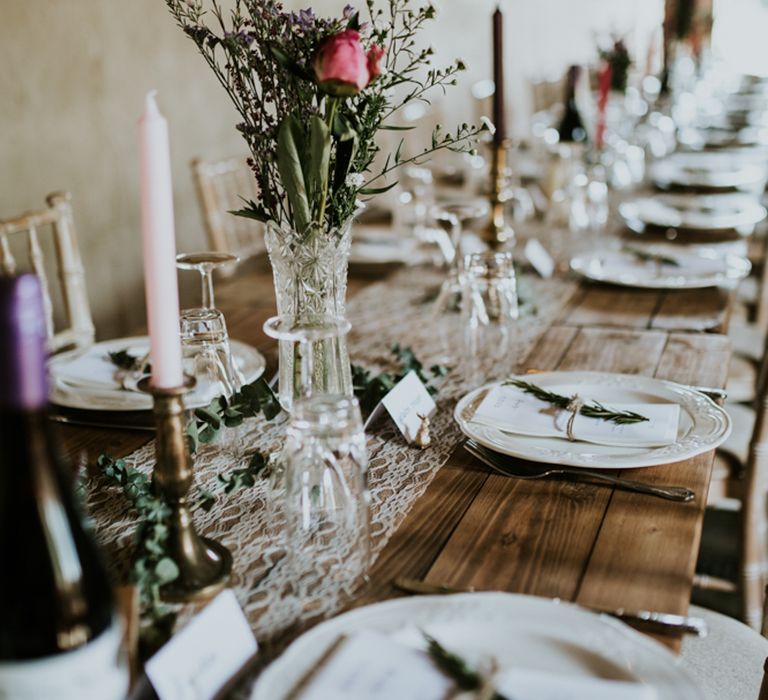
0,274 -> 128,700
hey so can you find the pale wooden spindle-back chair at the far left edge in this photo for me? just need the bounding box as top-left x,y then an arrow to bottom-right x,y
0,192 -> 95,353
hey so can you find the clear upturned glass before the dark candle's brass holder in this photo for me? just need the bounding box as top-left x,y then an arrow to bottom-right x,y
461,252 -> 519,384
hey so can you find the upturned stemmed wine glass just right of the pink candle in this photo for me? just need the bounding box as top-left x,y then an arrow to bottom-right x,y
176,252 -> 244,400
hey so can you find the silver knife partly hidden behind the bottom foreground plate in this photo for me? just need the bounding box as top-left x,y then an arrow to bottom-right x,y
392,577 -> 707,637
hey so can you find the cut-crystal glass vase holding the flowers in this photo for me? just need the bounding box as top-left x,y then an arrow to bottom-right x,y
265,219 -> 352,411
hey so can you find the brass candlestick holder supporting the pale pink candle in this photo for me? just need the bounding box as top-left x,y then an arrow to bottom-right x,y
139,377 -> 232,602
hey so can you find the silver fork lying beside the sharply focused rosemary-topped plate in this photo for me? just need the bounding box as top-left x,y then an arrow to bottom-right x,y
463,440 -> 696,503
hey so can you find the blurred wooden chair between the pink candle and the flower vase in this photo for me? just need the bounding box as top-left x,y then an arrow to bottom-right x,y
191,157 -> 266,275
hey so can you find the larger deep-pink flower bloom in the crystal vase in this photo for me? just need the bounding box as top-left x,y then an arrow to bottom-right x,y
312,29 -> 371,96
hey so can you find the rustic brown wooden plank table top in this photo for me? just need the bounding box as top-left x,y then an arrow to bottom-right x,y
60,258 -> 730,653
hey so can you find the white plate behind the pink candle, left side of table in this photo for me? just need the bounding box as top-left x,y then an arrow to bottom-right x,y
48,336 -> 266,411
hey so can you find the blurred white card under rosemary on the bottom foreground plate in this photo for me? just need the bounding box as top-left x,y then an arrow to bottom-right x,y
289,630 -> 657,700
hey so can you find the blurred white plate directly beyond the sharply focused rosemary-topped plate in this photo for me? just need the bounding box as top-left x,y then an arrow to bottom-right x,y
571,246 -> 752,289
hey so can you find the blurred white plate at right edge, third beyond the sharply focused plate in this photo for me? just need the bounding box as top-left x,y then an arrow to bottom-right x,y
651,151 -> 766,191
